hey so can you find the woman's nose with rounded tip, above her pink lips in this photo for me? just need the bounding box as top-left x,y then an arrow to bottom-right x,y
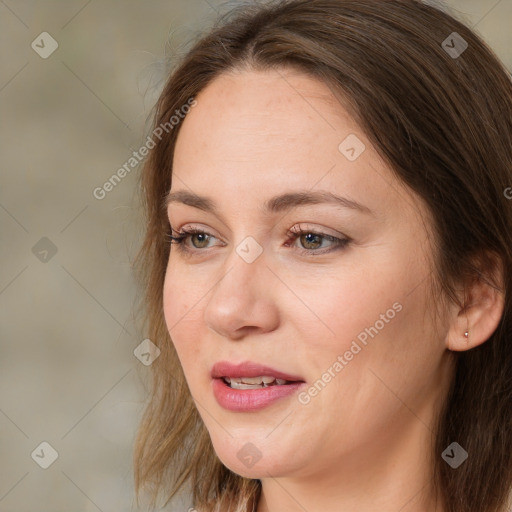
204,247 -> 279,340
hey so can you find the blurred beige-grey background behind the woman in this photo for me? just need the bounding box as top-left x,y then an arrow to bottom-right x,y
0,0 -> 512,512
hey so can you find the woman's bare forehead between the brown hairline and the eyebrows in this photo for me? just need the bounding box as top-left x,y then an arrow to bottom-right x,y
171,66 -> 424,232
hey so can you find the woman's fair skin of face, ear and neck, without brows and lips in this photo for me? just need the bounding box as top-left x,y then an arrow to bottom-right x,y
164,69 -> 502,512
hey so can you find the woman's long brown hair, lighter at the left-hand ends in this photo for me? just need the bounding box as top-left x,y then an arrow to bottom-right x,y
134,0 -> 512,512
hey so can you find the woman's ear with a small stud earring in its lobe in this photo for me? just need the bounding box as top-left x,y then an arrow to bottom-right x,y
445,252 -> 505,351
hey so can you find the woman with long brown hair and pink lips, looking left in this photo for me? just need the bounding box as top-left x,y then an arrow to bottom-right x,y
134,0 -> 512,512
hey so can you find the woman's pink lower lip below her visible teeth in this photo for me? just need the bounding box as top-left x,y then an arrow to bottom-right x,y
212,379 -> 306,412
